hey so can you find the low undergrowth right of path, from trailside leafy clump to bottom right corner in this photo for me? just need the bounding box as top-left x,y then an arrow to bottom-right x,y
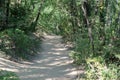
69,51 -> 120,80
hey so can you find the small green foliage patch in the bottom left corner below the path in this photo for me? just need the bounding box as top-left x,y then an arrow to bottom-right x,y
0,70 -> 20,80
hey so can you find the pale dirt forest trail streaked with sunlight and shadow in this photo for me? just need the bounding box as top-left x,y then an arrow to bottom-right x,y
0,36 -> 84,80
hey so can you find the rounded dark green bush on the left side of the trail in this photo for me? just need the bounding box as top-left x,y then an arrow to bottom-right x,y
1,29 -> 40,59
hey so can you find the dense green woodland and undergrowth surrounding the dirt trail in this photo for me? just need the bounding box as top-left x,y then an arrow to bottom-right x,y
0,0 -> 120,80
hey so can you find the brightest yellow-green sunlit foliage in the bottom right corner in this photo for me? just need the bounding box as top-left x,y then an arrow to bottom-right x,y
86,57 -> 120,80
